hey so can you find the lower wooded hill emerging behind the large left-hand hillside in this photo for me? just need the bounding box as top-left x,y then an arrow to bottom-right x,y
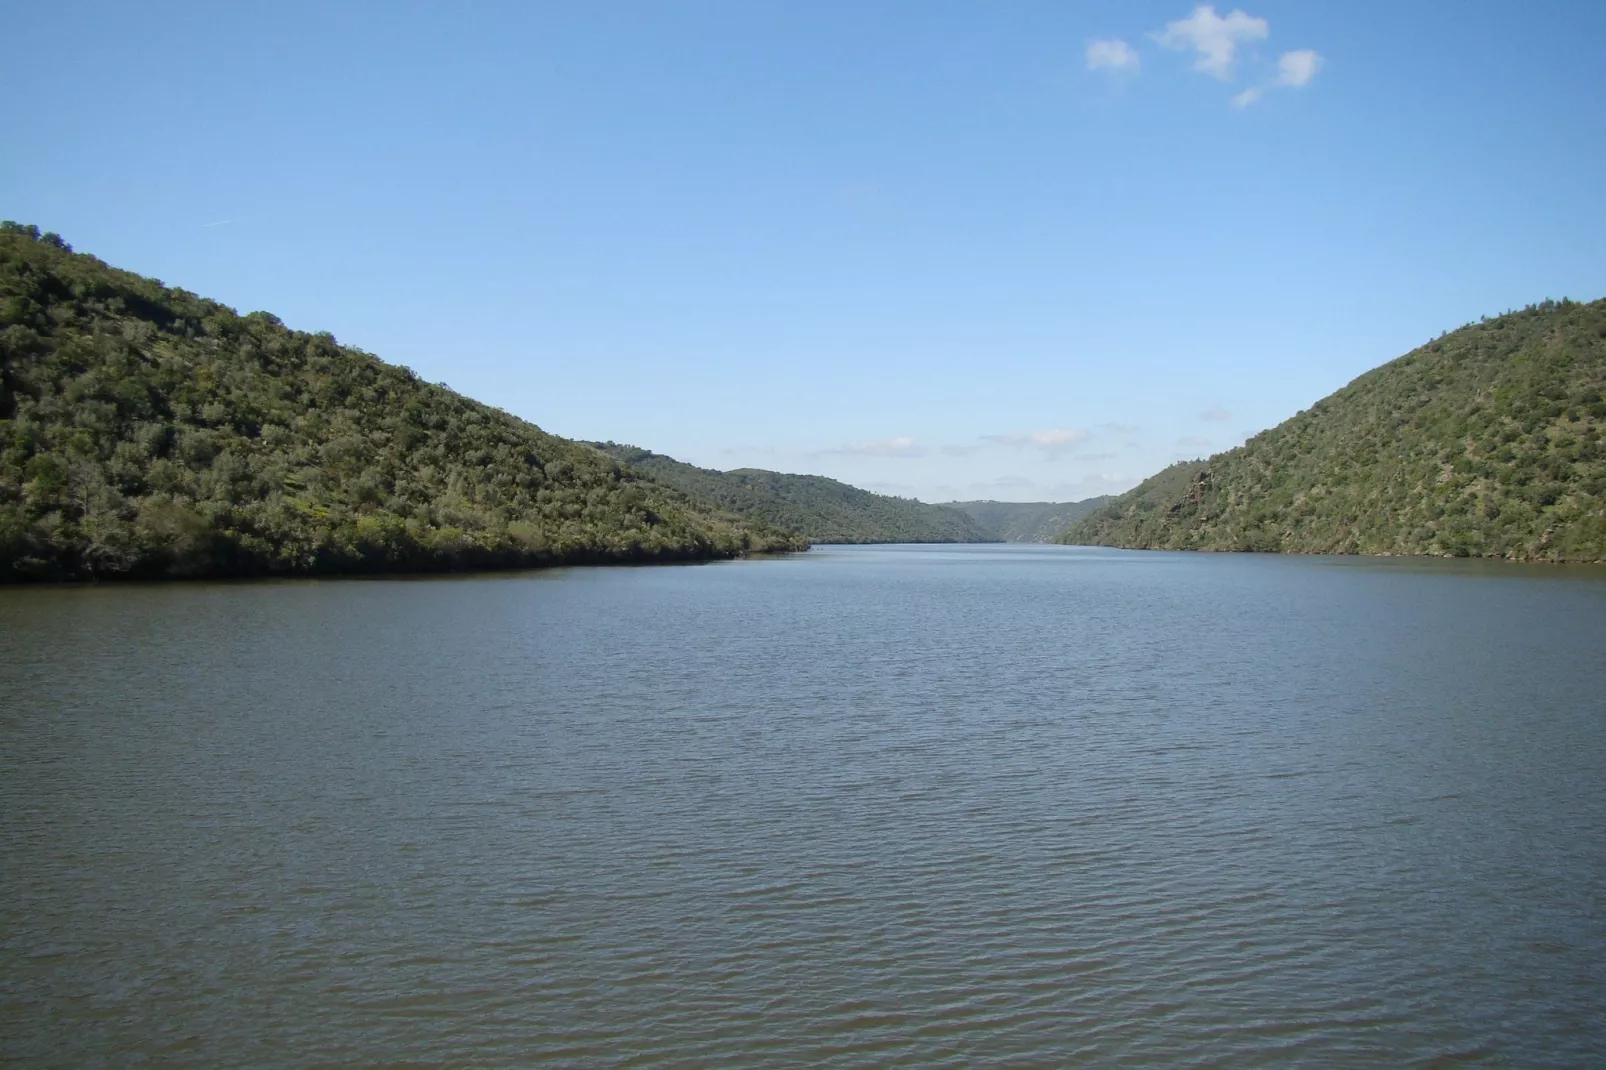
593,442 -> 999,543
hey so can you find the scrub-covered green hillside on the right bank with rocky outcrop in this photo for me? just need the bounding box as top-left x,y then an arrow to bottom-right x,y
1062,300 -> 1606,561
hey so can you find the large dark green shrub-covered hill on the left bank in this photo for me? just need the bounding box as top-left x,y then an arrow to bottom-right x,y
0,223 -> 803,580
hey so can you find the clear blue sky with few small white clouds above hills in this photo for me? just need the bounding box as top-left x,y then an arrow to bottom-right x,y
0,0 -> 1606,501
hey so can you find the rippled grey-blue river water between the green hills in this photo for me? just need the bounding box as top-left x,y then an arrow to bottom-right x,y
0,546 -> 1606,1067
